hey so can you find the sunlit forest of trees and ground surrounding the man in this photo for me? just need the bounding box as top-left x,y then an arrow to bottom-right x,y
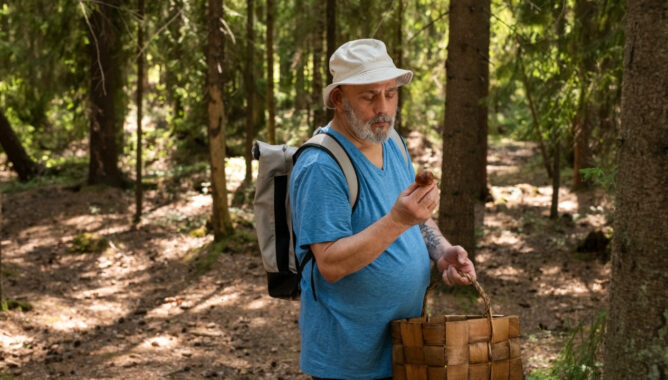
0,0 -> 668,379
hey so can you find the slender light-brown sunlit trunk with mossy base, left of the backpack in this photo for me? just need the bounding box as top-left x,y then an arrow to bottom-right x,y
206,0 -> 232,241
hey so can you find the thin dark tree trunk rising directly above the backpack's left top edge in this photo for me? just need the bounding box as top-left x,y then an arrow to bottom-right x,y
244,0 -> 255,184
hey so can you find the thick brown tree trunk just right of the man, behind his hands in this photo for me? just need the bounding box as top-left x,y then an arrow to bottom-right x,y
439,1 -> 490,258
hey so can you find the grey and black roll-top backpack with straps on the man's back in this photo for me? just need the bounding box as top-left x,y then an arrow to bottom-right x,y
253,128 -> 409,300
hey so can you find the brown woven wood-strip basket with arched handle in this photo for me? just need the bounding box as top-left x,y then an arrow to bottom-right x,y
390,276 -> 523,380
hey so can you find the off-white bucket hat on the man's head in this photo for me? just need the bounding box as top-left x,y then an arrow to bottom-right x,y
322,39 -> 413,108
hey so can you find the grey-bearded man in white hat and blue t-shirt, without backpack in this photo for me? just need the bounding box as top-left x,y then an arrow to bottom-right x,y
290,39 -> 475,379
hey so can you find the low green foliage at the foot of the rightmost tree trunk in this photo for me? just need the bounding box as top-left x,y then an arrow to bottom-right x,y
527,312 -> 606,380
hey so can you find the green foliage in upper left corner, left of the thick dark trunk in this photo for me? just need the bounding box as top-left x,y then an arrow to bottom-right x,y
0,0 -> 88,160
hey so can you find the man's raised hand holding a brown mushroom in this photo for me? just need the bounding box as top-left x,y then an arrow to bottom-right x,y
389,181 -> 440,227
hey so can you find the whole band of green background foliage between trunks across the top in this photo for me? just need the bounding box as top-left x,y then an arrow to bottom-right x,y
0,0 -> 624,196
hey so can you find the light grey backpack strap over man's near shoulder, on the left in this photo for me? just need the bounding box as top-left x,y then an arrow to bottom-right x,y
292,132 -> 359,209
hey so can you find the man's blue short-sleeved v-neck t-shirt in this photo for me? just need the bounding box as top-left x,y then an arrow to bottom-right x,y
290,126 -> 429,379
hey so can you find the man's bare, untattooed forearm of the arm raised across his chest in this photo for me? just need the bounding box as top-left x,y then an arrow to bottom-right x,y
311,214 -> 410,282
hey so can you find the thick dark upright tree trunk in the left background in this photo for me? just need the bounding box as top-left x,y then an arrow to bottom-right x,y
88,1 -> 123,186
